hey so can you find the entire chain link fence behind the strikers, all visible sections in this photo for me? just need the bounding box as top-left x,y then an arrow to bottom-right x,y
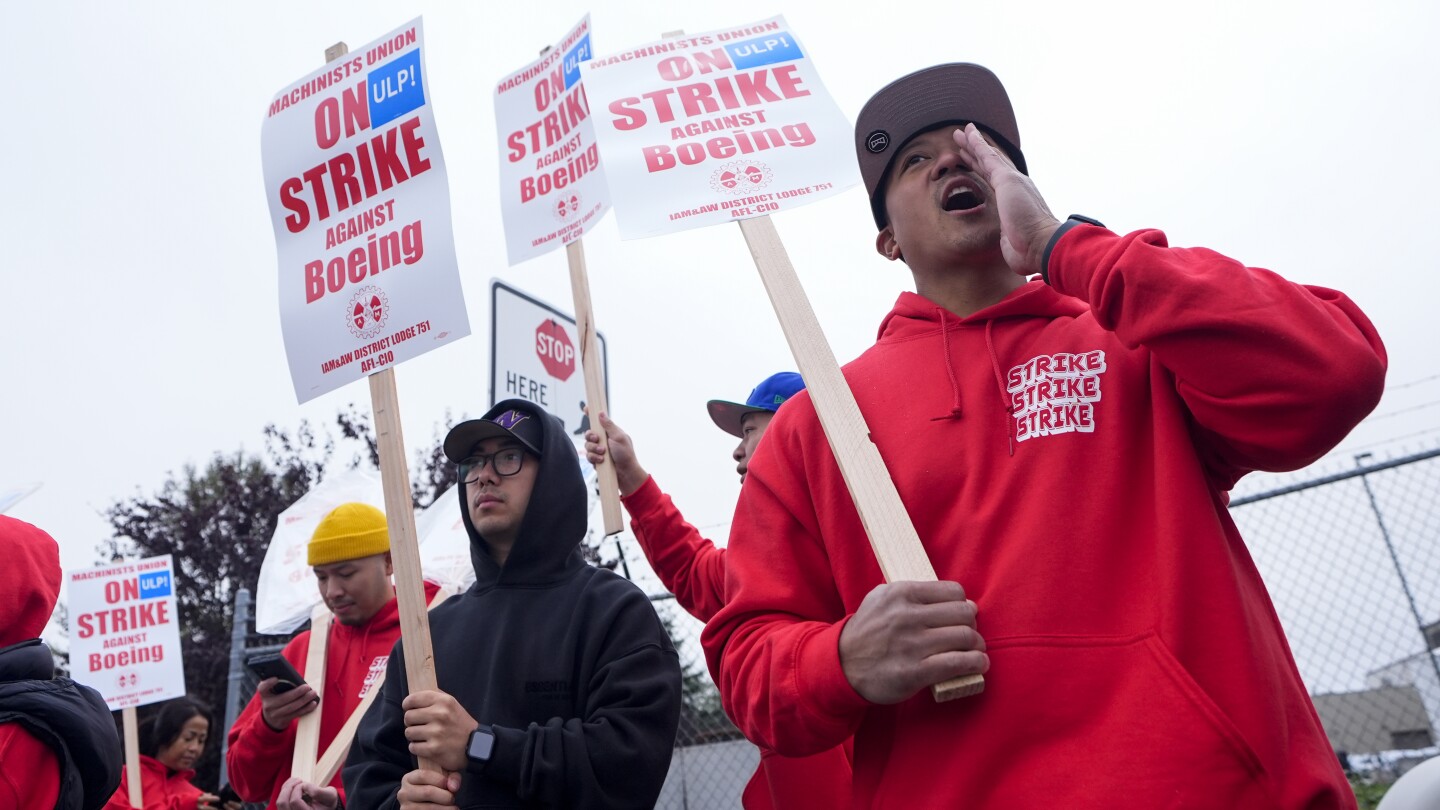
218,448 -> 1440,810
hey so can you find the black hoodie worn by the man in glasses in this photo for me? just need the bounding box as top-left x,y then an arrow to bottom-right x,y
344,401 -> 680,809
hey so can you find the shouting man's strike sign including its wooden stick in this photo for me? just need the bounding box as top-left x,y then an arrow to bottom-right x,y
586,17 -> 985,700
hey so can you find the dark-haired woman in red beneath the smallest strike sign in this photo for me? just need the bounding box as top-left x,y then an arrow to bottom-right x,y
105,698 -> 240,810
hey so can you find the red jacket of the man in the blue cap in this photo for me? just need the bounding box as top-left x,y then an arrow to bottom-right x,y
621,479 -> 850,810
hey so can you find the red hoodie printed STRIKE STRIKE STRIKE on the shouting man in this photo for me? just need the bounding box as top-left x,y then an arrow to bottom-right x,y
703,226 -> 1385,810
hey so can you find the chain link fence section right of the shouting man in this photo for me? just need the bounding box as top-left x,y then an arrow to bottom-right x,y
1230,448 -> 1440,807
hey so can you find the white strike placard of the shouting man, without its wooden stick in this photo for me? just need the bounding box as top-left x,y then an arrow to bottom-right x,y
582,17 -> 860,239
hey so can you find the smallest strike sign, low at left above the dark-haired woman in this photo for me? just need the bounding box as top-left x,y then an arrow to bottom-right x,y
65,553 -> 186,711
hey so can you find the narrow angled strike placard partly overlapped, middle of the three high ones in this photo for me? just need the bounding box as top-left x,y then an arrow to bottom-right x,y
495,16 -> 611,265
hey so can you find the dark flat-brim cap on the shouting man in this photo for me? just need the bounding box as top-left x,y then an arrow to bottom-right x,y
855,62 -> 1030,228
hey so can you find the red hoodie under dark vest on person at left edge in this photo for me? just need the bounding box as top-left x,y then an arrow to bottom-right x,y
0,515 -> 60,807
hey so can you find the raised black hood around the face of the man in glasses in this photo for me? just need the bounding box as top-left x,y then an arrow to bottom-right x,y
455,399 -> 586,588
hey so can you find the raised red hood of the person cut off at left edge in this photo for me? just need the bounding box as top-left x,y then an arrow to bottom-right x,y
0,515 -> 60,647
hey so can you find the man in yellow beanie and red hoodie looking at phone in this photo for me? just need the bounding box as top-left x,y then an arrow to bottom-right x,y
225,503 -> 439,807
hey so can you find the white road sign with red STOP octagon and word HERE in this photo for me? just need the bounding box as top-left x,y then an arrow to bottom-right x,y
490,280 -> 609,435
